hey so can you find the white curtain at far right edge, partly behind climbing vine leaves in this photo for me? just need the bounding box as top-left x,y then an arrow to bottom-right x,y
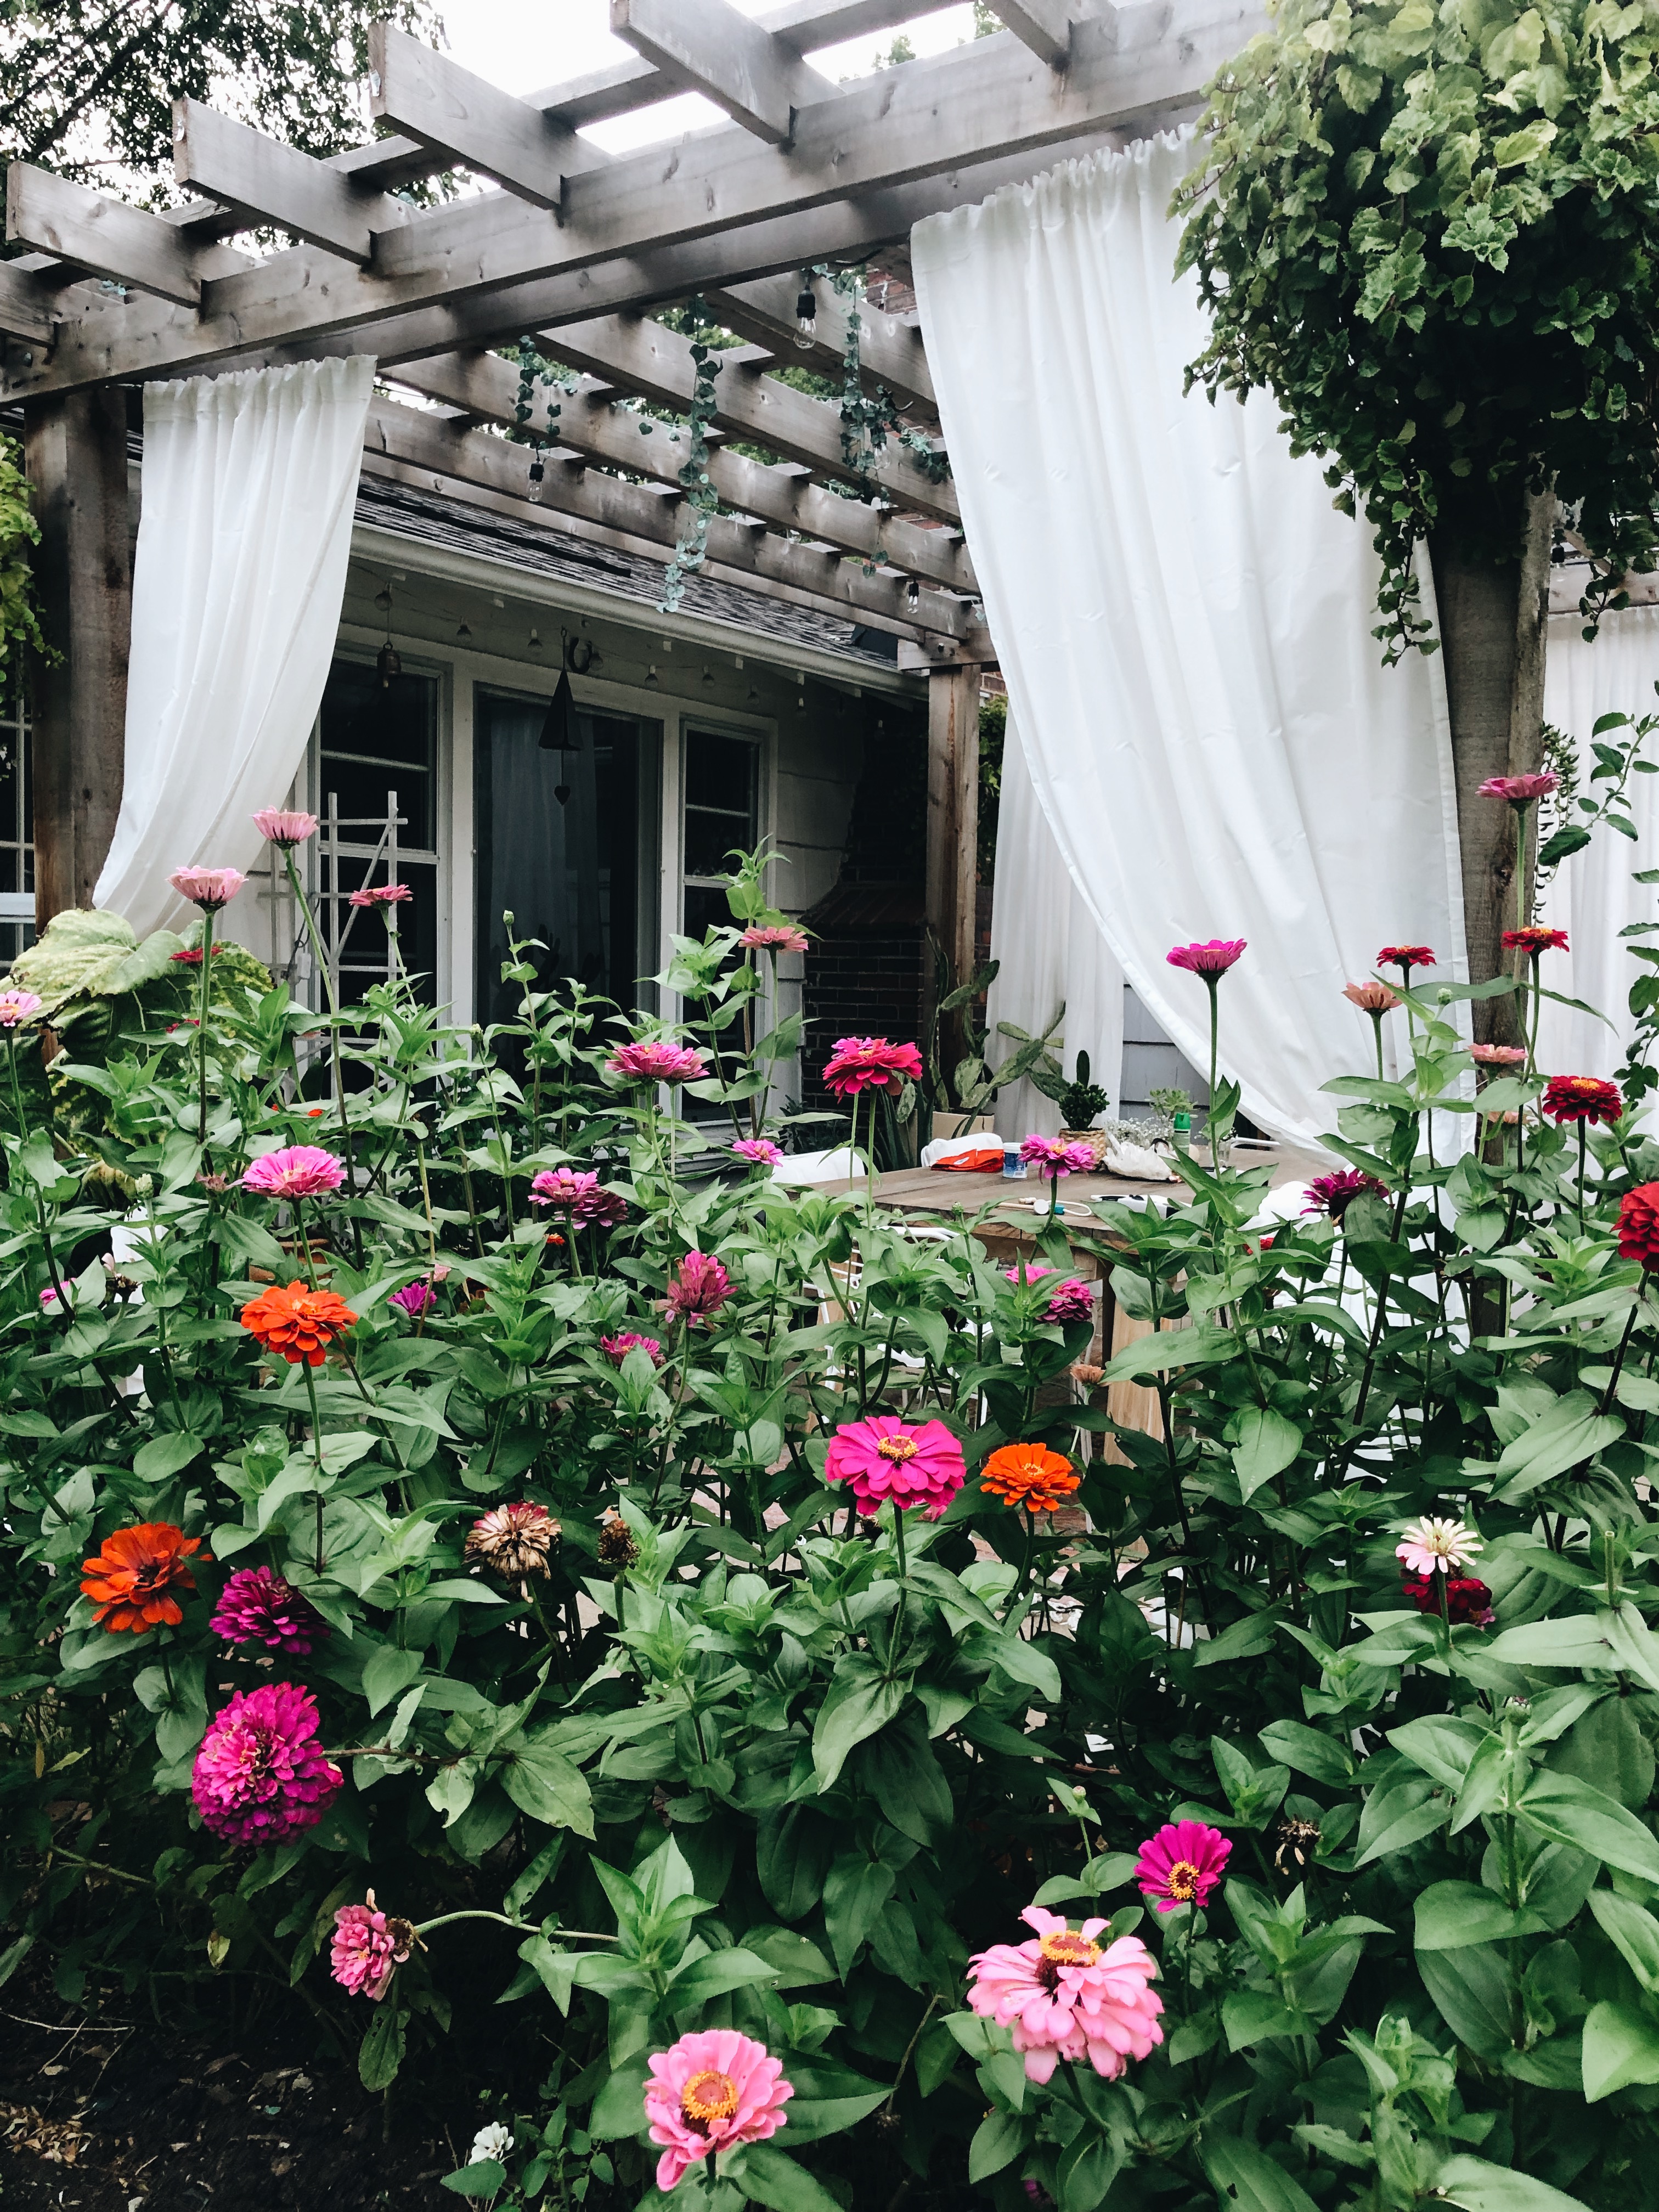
1537,606 -> 1659,1075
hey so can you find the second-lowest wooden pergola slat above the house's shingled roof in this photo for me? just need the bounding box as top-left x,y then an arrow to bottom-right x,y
396,354 -> 978,597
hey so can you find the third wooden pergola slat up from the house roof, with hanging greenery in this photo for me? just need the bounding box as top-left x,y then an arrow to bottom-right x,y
546,314 -> 962,529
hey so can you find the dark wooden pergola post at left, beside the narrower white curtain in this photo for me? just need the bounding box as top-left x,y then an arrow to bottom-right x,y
24,385 -> 133,929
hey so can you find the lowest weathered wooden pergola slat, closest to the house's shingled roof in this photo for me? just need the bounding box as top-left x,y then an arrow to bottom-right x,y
365,400 -> 969,635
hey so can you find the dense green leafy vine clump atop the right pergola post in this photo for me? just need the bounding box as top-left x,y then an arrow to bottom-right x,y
1175,0 -> 1659,657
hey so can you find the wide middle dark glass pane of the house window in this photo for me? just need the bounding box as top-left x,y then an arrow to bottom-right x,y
473,690 -> 662,1022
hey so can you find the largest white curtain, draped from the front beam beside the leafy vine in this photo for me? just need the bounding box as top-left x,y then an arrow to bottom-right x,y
911,137 -> 1464,1142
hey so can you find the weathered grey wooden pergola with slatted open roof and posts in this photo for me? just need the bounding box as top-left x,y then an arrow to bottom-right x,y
0,0 -> 1261,995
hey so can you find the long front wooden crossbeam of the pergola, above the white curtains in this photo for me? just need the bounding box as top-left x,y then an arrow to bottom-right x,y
7,0 -> 1256,396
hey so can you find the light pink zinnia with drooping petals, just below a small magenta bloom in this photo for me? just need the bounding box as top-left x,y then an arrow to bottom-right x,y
969,1905 -> 1164,2081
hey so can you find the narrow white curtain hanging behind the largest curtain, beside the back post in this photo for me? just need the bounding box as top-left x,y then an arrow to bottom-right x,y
986,714 -> 1124,1137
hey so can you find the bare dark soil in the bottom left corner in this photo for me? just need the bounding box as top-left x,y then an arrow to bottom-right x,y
0,1976 -> 493,2212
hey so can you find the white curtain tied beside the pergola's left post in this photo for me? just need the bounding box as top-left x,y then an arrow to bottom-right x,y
95,354 -> 374,936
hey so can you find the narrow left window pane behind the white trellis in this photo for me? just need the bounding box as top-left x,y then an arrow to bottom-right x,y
307,659 -> 438,1005
